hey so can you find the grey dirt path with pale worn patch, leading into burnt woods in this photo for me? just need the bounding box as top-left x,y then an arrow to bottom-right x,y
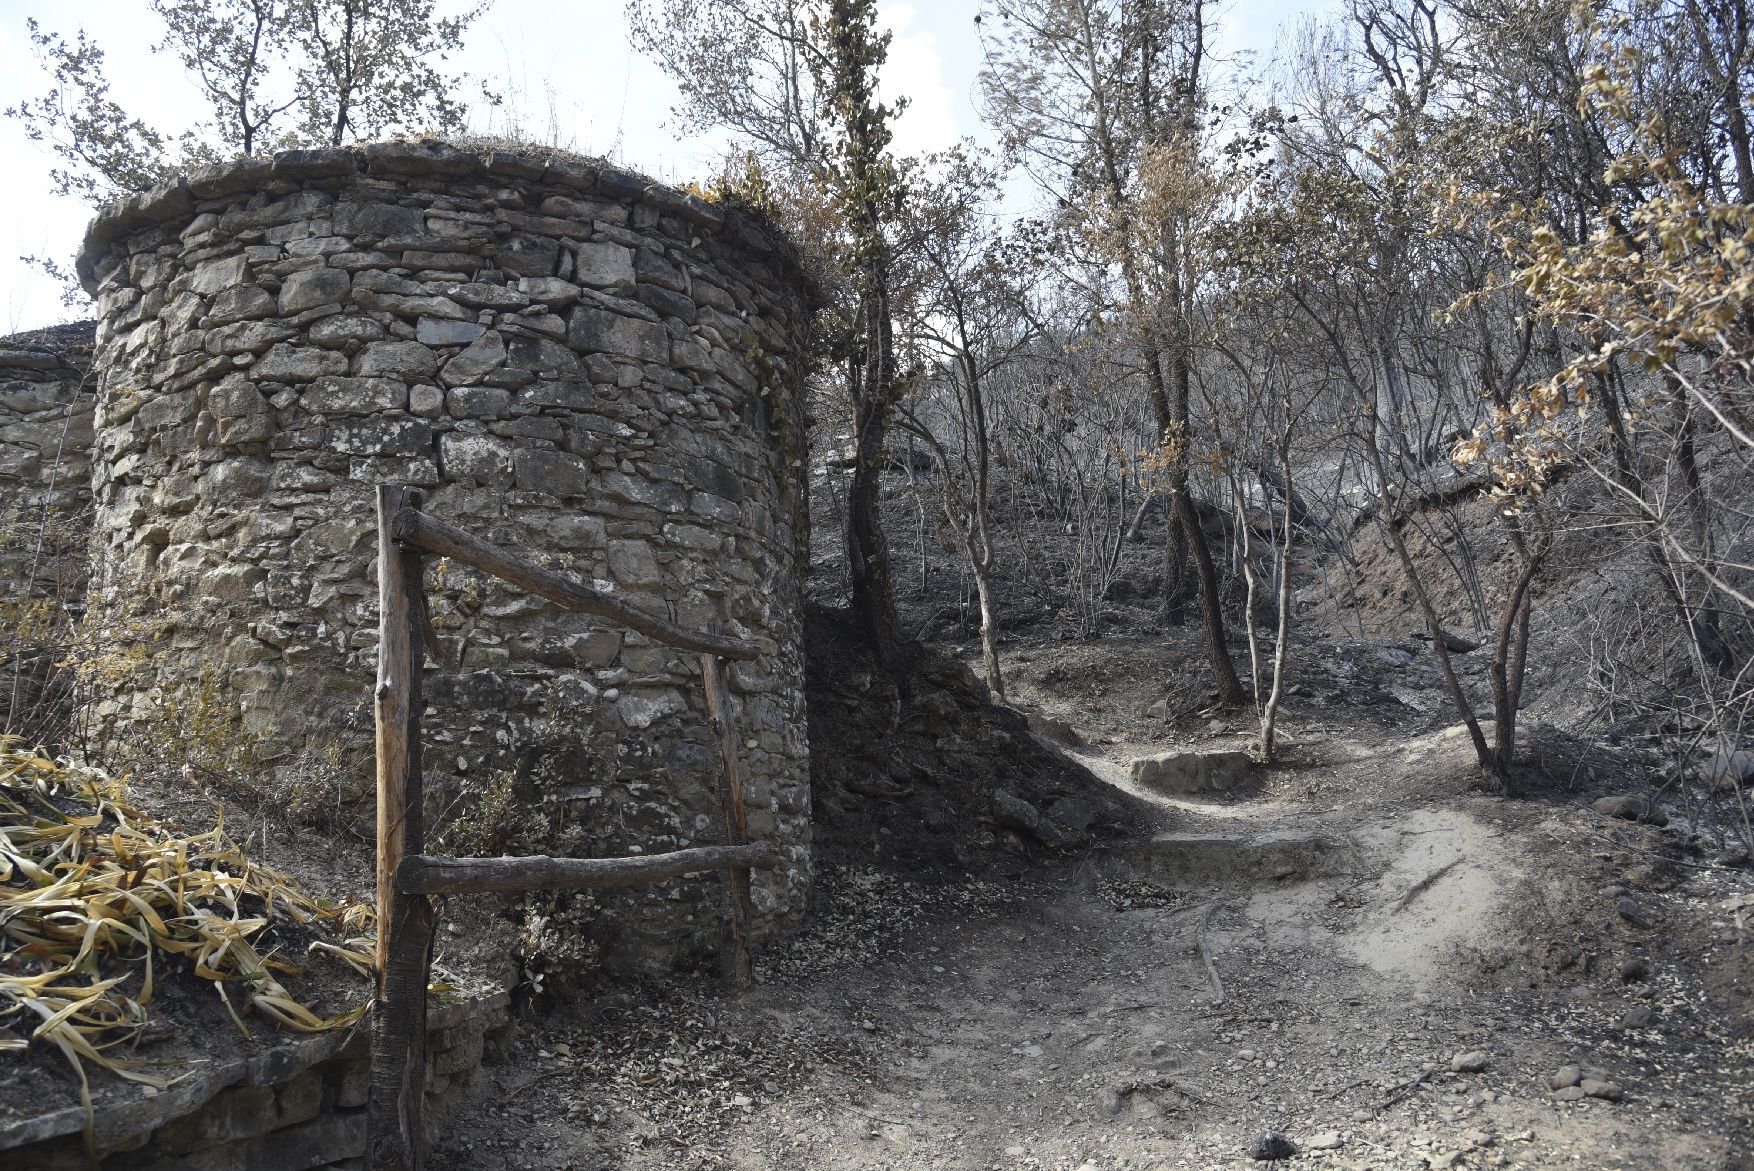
437,715 -> 1754,1171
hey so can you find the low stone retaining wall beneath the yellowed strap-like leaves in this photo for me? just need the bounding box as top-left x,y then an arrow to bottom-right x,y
0,994 -> 507,1171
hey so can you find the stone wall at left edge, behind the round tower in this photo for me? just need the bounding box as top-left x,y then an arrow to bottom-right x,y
0,323 -> 96,743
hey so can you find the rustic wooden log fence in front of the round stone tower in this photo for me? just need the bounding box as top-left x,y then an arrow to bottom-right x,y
367,486 -> 777,1171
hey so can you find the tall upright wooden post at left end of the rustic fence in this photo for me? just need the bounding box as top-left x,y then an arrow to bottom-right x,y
367,486 -> 433,1171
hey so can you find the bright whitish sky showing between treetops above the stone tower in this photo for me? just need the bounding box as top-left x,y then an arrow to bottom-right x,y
0,0 -> 1331,335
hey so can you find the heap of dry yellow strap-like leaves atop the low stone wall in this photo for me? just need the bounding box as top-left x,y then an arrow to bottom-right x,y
0,736 -> 374,1135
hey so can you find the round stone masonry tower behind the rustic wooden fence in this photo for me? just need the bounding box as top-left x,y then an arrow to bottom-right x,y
79,144 -> 810,966
